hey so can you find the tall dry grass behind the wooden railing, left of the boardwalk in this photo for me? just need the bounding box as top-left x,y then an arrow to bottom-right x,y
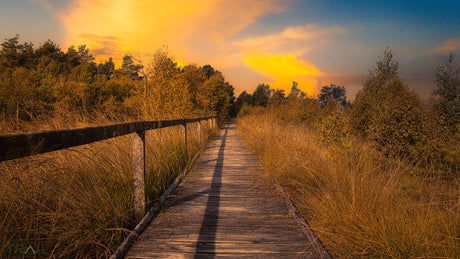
0,115 -> 217,258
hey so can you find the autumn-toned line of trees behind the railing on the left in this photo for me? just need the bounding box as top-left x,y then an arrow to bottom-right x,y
0,36 -> 234,130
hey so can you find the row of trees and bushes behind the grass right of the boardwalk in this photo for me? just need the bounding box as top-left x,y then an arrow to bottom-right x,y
235,49 -> 460,174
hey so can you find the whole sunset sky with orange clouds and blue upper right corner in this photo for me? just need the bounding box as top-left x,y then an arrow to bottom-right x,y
0,0 -> 460,99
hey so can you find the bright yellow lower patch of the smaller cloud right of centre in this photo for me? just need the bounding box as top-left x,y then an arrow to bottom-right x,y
242,54 -> 324,96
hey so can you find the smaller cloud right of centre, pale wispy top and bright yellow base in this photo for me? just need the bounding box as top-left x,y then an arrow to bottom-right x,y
237,24 -> 345,95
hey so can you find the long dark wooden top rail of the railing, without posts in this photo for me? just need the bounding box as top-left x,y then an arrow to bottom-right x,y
0,118 -> 215,162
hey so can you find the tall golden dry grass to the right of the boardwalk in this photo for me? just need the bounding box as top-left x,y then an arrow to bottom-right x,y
238,112 -> 460,258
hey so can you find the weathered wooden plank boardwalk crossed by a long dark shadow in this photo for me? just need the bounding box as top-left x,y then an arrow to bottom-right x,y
127,123 -> 327,258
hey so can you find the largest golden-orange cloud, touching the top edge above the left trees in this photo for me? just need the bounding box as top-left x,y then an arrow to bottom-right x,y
59,0 -> 286,63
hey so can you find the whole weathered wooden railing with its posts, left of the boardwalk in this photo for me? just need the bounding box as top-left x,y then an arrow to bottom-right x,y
0,116 -> 216,219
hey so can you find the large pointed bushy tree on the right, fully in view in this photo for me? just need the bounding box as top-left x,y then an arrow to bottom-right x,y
350,49 -> 423,156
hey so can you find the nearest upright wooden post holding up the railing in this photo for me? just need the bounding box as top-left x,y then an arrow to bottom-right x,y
133,131 -> 145,221
